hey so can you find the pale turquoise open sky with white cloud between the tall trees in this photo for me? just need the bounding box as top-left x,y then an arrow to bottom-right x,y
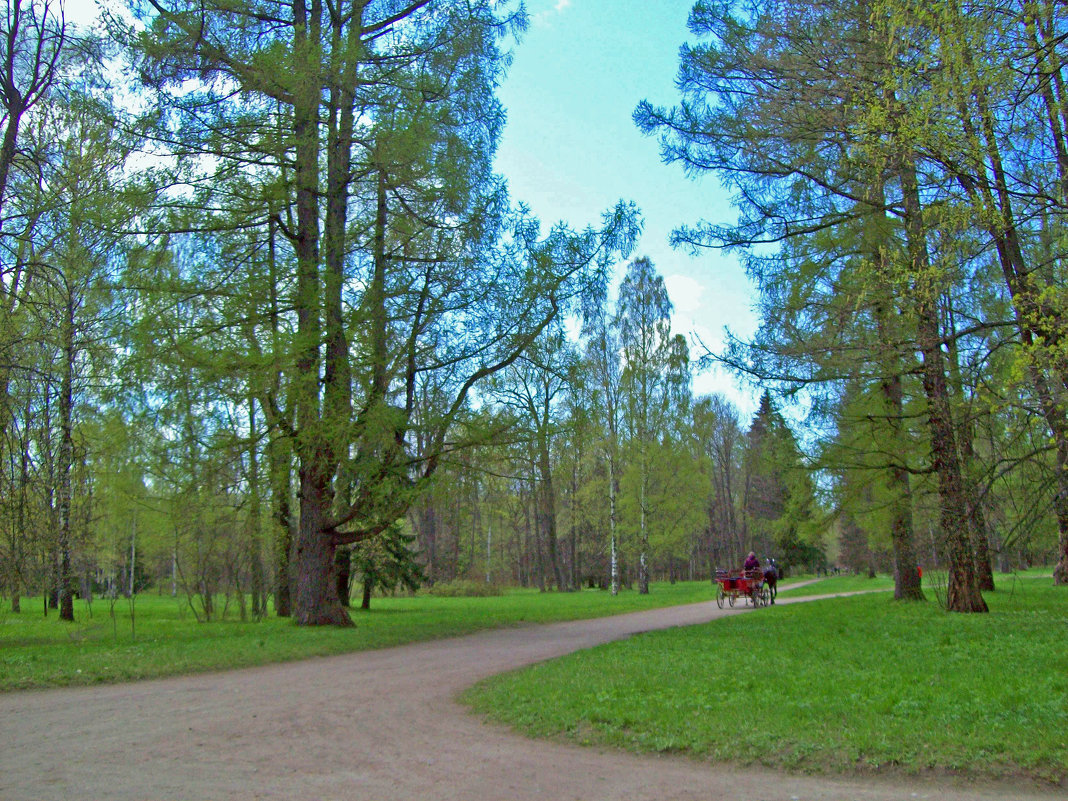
497,0 -> 756,414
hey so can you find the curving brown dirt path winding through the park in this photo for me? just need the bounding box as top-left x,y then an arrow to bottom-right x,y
0,598 -> 1050,801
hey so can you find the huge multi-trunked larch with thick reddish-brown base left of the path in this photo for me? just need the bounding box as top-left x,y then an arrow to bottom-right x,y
119,0 -> 632,625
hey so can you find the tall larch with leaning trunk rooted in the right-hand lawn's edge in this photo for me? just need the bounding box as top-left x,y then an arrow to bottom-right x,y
635,0 -> 985,612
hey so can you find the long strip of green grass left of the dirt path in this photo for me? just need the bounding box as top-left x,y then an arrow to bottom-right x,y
0,582 -> 713,691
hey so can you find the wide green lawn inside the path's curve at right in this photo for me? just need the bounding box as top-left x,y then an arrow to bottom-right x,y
465,574 -> 1068,784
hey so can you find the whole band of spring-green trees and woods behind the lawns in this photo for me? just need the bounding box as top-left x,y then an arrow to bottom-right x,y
0,0 -> 1068,625
